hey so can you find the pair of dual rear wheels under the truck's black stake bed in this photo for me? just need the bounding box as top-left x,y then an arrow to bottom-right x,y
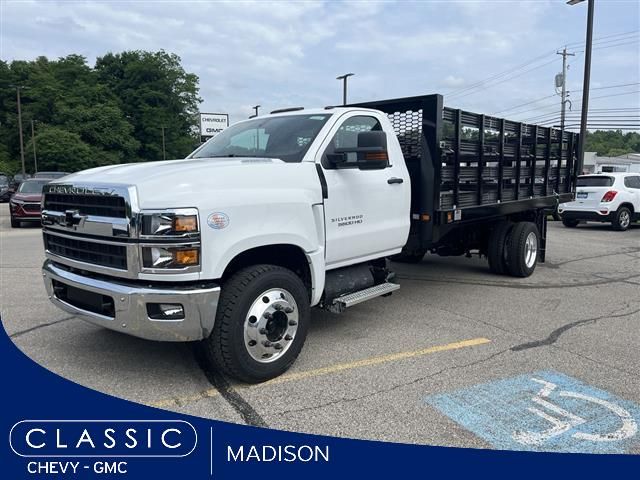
487,222 -> 540,277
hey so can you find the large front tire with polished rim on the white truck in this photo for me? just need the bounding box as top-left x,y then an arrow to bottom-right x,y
203,265 -> 311,383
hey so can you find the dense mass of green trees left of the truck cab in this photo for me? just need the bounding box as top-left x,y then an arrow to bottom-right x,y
0,52 -> 201,173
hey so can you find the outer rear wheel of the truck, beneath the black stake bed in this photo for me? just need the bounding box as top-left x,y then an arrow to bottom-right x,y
507,222 -> 540,278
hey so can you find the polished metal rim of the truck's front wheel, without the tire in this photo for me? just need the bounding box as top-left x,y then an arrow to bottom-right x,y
244,288 -> 298,363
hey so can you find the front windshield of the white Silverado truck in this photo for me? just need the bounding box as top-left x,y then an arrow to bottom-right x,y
190,114 -> 331,162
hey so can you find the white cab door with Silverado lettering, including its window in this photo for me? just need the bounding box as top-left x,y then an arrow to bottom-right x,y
316,111 -> 411,269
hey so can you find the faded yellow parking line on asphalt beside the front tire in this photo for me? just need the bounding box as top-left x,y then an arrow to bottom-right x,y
149,338 -> 491,408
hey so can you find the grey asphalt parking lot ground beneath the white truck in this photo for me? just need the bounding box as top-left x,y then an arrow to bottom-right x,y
0,204 -> 640,453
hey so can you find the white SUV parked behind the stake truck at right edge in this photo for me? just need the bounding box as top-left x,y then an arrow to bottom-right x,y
558,173 -> 640,231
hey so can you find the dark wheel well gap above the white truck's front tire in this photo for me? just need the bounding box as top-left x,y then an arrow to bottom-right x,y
222,244 -> 311,291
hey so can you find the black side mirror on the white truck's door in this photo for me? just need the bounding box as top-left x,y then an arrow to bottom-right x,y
327,130 -> 389,170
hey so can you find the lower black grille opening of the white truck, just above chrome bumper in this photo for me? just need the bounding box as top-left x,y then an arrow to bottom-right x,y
44,232 -> 127,270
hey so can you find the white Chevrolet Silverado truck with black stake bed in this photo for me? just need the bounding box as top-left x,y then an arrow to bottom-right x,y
42,95 -> 577,382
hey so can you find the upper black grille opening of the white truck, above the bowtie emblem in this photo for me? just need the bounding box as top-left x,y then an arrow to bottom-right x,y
44,193 -> 127,218
